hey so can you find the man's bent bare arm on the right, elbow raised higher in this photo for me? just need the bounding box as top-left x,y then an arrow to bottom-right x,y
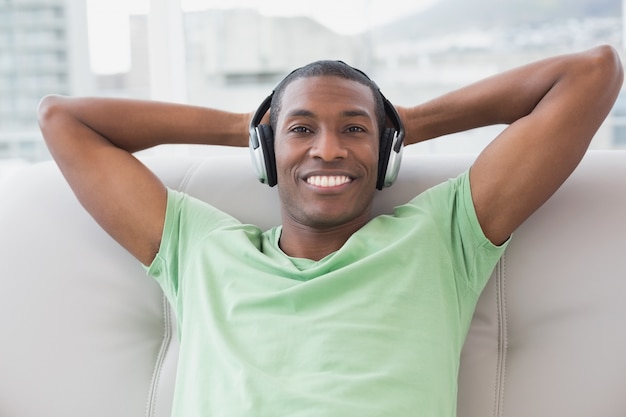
399,46 -> 623,244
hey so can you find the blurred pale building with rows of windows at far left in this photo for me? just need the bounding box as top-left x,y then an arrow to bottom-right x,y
0,0 -> 93,161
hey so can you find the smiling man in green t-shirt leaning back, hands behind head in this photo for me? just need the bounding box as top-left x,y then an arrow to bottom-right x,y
40,46 -> 623,417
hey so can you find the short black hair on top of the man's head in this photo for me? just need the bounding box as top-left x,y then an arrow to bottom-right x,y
270,60 -> 386,134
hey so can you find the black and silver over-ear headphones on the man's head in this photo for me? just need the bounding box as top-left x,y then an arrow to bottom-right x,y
249,61 -> 404,190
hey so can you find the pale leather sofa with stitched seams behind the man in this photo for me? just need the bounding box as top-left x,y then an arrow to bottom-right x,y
0,151 -> 626,417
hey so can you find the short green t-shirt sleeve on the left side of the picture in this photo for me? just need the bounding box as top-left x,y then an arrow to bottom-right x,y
144,189 -> 238,304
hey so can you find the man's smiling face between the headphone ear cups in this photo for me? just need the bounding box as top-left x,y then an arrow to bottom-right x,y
274,76 -> 379,230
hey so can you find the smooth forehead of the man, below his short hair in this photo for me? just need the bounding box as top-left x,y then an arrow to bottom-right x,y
280,76 -> 376,118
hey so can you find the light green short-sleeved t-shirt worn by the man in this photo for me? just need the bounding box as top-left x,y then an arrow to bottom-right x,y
148,173 -> 504,417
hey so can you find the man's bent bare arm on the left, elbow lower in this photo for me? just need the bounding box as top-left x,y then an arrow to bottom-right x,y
39,96 -> 249,265
